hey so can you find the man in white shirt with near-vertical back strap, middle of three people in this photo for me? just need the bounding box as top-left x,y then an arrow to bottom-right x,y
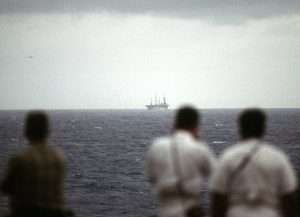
146,106 -> 215,217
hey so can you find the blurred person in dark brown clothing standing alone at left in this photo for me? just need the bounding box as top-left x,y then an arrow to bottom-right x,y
1,111 -> 71,217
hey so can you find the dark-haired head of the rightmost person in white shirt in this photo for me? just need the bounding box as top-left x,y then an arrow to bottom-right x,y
239,108 -> 267,139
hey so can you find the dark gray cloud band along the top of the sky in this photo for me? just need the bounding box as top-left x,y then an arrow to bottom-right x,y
0,0 -> 300,22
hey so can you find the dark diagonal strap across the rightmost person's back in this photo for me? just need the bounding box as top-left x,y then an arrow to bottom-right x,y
227,142 -> 261,191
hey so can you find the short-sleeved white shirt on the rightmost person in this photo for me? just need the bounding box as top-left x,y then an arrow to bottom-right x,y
211,139 -> 297,217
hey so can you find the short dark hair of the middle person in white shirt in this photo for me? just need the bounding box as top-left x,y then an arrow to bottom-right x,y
175,106 -> 200,130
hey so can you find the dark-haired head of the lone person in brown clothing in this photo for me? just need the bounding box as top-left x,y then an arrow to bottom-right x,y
24,111 -> 49,141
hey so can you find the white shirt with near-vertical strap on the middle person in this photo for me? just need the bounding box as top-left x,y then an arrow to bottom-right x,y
146,131 -> 215,217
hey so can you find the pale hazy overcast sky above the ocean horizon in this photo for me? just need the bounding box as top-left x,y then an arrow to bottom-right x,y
0,0 -> 300,109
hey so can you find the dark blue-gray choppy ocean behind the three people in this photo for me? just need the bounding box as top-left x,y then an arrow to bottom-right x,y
0,109 -> 300,217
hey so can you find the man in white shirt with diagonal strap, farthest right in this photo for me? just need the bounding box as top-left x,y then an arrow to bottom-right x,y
211,108 -> 297,217
